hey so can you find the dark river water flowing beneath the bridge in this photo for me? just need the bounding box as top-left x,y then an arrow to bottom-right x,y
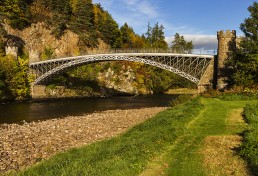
0,95 -> 177,124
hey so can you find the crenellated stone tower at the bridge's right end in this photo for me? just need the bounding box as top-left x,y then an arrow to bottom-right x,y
217,30 -> 236,90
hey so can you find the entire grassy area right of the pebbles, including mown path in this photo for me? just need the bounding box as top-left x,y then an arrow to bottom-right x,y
8,98 -> 258,176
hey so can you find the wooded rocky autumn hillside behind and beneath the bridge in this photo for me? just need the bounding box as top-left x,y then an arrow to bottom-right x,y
0,0 -> 194,100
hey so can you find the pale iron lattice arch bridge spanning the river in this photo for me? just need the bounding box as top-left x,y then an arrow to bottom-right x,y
30,53 -> 214,85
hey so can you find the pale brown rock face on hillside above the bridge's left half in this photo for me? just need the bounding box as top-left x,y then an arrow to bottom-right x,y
4,22 -> 109,62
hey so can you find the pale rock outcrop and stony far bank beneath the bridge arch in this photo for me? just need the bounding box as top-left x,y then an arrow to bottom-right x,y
32,62 -> 153,99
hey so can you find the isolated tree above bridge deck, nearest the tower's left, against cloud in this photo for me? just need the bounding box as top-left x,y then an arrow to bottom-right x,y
171,33 -> 194,53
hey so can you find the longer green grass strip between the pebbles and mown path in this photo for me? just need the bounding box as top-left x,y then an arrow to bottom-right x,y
16,99 -> 203,176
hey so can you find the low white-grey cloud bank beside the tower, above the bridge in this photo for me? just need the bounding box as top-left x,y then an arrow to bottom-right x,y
166,34 -> 218,50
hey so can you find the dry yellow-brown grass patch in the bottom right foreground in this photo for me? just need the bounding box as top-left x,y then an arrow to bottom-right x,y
202,135 -> 250,176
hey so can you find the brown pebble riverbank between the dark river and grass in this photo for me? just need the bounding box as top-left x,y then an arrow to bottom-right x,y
0,107 -> 166,175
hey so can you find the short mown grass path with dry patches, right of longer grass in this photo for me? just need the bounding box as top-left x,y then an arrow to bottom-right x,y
140,99 -> 252,176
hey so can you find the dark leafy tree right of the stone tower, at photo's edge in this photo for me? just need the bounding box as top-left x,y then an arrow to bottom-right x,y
226,2 -> 258,89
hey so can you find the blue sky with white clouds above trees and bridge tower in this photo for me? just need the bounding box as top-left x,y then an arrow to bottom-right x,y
93,0 -> 255,50
